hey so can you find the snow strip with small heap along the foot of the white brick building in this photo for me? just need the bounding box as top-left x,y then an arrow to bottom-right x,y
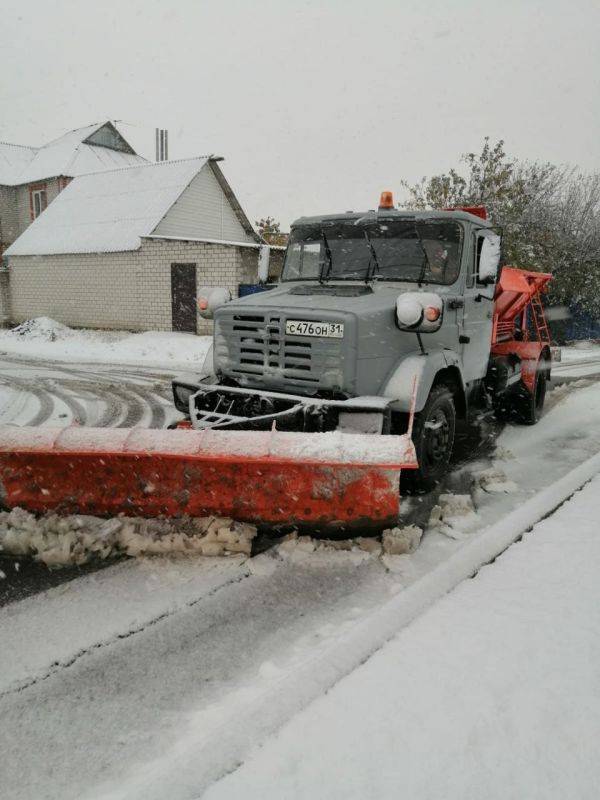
0,317 -> 211,370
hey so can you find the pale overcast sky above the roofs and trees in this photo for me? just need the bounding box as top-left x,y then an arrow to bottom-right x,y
0,0 -> 600,227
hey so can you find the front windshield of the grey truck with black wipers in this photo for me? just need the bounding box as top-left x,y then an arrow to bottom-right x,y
282,219 -> 462,284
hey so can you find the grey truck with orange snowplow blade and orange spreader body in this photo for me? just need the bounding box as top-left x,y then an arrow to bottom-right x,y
0,192 -> 552,532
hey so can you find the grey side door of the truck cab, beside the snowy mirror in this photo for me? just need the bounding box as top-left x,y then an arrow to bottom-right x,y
459,229 -> 498,383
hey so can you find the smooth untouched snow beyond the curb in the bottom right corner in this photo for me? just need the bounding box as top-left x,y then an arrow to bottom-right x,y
204,478 -> 600,800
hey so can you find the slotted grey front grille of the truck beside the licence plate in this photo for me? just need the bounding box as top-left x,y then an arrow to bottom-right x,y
215,314 -> 343,388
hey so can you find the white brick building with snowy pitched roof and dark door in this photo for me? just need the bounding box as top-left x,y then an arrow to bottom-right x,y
3,141 -> 280,333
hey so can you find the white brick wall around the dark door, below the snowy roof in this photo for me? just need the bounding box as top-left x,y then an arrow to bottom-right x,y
9,240 -> 258,333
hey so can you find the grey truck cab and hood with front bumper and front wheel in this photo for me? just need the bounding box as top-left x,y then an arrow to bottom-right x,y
174,193 -> 516,489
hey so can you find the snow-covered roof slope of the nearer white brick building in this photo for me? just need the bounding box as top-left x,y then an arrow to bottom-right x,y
4,156 -> 210,256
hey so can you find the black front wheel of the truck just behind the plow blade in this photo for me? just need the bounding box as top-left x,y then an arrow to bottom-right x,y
402,385 -> 456,492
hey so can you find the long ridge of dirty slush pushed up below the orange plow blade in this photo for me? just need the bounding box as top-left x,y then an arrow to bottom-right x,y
0,508 -> 256,567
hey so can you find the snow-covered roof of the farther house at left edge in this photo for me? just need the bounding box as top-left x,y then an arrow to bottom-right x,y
0,122 -> 148,186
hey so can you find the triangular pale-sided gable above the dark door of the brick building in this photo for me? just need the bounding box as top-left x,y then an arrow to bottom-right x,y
152,164 -> 257,244
